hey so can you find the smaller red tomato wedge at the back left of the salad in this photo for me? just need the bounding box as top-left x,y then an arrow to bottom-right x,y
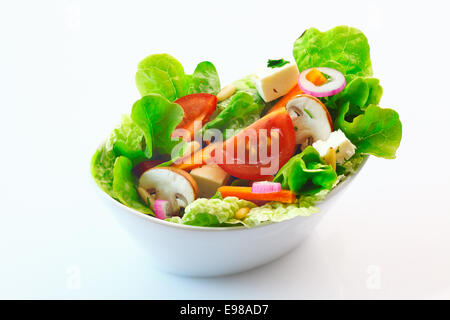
171,93 -> 217,139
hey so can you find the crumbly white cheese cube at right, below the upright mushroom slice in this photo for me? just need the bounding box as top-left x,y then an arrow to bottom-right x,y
313,130 -> 356,164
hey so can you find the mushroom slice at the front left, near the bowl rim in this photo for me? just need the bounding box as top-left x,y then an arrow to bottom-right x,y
138,167 -> 198,217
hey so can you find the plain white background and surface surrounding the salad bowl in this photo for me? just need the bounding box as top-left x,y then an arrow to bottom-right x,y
0,0 -> 450,299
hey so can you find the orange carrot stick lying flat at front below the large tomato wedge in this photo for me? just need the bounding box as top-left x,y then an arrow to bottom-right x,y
217,186 -> 297,203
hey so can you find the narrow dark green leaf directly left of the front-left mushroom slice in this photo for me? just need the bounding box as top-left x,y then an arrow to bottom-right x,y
113,156 -> 153,215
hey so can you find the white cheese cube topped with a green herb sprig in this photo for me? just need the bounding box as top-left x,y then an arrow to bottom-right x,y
253,62 -> 298,102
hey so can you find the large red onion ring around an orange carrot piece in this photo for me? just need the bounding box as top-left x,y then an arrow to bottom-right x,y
298,68 -> 346,98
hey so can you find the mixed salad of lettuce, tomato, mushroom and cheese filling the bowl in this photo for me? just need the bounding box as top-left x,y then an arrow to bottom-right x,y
91,26 -> 402,227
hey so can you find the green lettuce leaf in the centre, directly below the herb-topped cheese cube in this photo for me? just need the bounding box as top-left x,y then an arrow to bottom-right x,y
202,91 -> 261,140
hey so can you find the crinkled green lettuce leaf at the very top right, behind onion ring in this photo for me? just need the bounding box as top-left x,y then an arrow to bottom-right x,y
293,26 -> 372,76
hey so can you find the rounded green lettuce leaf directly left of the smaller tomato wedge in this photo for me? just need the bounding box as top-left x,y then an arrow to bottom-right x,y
131,94 -> 184,157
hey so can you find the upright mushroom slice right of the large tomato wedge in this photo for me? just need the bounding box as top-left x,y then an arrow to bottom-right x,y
286,94 -> 333,149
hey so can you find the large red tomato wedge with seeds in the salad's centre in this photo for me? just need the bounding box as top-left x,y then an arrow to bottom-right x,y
213,108 -> 295,180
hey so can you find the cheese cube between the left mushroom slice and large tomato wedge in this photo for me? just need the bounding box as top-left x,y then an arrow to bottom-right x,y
190,164 -> 230,198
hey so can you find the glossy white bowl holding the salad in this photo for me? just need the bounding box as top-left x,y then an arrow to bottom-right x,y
99,159 -> 363,277
